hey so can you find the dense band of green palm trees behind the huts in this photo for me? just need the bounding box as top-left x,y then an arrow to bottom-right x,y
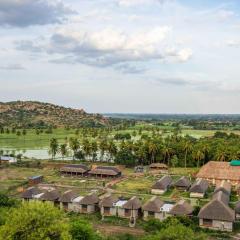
49,131 -> 240,167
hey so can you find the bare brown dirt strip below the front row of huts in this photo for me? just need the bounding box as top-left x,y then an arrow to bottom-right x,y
94,224 -> 145,236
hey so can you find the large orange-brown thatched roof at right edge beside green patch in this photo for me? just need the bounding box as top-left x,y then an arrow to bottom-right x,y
197,161 -> 240,181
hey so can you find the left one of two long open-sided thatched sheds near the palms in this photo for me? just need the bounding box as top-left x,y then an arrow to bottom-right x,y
60,164 -> 89,176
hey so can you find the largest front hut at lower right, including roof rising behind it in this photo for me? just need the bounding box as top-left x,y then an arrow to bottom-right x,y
198,191 -> 235,231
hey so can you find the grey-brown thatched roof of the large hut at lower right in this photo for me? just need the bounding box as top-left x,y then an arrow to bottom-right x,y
198,199 -> 235,222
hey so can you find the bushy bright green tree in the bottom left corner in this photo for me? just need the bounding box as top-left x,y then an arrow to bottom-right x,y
0,202 -> 71,240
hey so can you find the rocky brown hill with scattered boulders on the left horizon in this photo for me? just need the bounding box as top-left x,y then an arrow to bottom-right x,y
0,101 -> 108,128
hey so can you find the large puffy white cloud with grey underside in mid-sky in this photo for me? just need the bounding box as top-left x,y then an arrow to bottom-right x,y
18,26 -> 192,67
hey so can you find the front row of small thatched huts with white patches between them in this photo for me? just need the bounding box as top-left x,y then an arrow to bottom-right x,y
22,186 -> 193,226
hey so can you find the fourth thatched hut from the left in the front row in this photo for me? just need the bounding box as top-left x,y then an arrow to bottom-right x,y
79,193 -> 99,213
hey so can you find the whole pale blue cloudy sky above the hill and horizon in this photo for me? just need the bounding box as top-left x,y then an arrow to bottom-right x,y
0,0 -> 240,114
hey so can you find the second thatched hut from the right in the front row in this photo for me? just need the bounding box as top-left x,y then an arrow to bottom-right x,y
142,196 -> 164,220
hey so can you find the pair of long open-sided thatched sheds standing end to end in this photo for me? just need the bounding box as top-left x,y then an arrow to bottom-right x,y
60,164 -> 122,178
